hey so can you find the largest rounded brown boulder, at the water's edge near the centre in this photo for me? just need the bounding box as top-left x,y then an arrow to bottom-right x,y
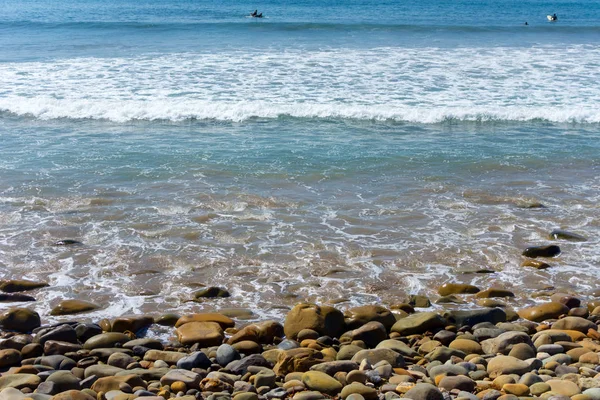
283,303 -> 346,339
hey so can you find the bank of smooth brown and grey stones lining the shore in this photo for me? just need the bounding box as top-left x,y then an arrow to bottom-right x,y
0,290 -> 600,400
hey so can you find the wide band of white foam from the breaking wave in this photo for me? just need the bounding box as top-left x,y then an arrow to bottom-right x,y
0,45 -> 600,123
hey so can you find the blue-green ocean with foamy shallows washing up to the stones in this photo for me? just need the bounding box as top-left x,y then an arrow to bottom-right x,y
0,0 -> 600,321
